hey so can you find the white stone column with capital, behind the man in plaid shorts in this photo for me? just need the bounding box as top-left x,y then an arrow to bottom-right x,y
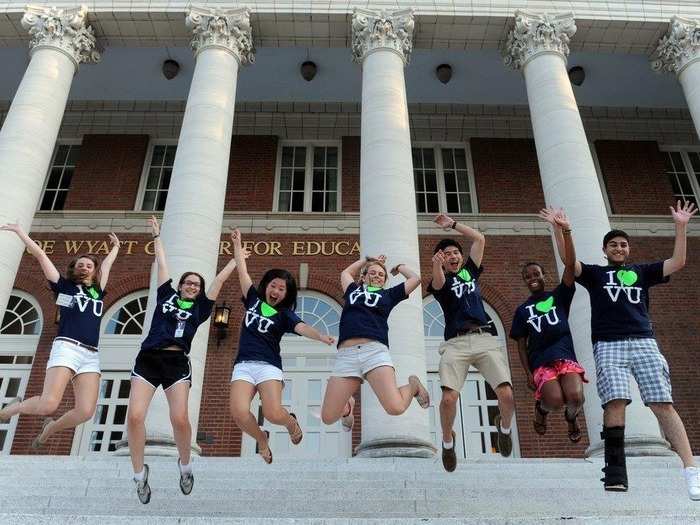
505,11 -> 670,455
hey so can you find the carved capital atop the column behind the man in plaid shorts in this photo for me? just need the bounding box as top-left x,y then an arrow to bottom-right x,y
504,11 -> 576,69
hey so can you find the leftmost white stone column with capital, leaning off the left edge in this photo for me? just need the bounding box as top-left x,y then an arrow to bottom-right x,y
0,6 -> 99,319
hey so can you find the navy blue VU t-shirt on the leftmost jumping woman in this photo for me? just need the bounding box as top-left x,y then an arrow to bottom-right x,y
49,277 -> 105,348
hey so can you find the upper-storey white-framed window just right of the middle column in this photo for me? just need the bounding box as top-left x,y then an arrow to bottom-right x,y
413,145 -> 476,214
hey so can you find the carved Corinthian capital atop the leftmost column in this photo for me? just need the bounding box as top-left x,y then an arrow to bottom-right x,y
22,5 -> 100,68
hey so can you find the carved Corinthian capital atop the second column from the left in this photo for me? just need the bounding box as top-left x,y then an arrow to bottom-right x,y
185,7 -> 255,65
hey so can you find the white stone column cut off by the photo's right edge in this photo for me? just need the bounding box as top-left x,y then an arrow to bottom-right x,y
651,16 -> 700,137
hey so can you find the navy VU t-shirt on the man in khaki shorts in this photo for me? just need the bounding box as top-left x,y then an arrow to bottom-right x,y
428,257 -> 488,341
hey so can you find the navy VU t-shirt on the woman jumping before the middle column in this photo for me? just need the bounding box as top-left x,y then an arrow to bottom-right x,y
338,283 -> 408,346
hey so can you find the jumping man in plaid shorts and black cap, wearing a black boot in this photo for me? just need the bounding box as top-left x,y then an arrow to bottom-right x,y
576,201 -> 700,500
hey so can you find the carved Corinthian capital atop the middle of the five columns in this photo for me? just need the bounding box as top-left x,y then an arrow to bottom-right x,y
352,8 -> 415,64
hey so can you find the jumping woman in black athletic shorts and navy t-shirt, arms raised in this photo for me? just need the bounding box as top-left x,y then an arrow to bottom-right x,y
127,217 -> 241,504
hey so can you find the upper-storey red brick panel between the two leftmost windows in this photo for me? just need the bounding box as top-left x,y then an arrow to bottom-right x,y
65,135 -> 148,210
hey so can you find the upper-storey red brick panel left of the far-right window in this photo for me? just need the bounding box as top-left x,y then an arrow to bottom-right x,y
595,140 -> 674,215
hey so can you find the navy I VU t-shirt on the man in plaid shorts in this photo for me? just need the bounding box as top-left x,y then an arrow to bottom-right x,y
576,261 -> 669,343
